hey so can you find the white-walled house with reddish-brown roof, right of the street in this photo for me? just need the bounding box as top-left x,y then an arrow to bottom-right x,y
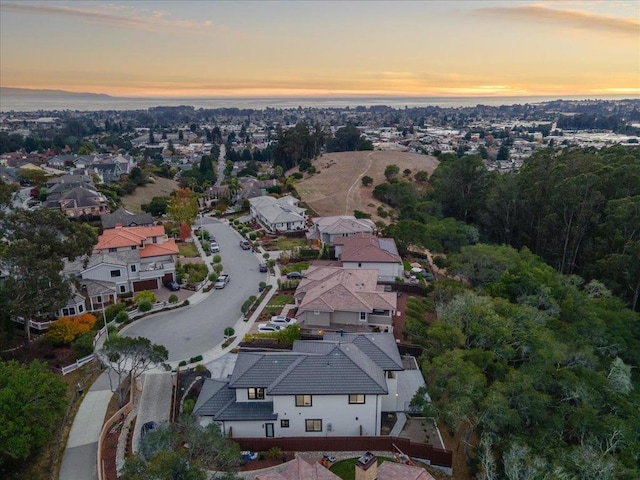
334,233 -> 404,281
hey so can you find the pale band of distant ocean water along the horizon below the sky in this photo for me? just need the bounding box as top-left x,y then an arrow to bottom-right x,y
0,95 -> 637,112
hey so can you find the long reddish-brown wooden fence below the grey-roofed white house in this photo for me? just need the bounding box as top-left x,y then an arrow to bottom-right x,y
231,436 -> 453,468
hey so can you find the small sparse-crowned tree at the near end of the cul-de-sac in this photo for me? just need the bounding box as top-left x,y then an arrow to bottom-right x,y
100,335 -> 169,407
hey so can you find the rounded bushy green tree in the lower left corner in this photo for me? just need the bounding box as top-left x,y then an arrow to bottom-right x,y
0,361 -> 67,464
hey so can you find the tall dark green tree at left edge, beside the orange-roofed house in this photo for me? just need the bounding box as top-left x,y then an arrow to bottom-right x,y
0,208 -> 96,348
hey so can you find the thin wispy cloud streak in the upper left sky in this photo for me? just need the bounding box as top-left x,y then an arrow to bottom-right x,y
0,2 -> 213,32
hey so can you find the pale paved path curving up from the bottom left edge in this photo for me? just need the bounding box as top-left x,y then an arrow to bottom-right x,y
58,372 -> 113,480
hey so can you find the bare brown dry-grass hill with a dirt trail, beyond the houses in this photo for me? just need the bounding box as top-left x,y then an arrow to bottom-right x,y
296,151 -> 438,221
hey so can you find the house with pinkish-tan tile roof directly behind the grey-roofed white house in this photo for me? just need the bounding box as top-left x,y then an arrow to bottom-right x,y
294,266 -> 398,331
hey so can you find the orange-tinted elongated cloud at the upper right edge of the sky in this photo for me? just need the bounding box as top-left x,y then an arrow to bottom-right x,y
476,5 -> 640,38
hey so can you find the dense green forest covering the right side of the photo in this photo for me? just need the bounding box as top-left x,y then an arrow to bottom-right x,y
374,147 -> 640,480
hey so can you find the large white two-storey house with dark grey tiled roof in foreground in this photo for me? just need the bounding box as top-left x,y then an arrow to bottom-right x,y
193,333 -> 403,438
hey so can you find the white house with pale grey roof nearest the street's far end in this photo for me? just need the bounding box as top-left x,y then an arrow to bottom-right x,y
249,195 -> 307,232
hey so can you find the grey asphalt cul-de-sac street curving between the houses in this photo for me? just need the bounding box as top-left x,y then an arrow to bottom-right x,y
122,217 -> 268,362
